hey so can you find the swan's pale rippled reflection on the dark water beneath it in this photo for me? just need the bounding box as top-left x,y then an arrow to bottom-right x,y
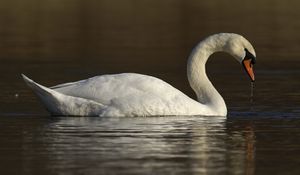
1,117 -> 240,174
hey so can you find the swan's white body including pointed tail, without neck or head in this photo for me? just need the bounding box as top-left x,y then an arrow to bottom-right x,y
24,73 -> 204,116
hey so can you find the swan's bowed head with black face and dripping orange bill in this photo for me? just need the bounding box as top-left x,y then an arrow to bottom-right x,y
224,34 -> 256,81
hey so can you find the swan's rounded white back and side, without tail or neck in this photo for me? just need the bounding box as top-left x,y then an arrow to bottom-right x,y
52,73 -> 202,116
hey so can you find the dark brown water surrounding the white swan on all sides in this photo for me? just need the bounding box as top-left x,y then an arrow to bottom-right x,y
0,0 -> 300,174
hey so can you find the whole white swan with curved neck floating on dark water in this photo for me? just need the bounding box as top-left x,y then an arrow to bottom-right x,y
22,33 -> 256,117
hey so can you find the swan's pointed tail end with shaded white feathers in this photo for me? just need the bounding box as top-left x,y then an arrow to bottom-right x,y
22,74 -> 105,116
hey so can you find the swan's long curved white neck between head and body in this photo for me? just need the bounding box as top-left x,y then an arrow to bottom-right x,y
187,37 -> 227,115
